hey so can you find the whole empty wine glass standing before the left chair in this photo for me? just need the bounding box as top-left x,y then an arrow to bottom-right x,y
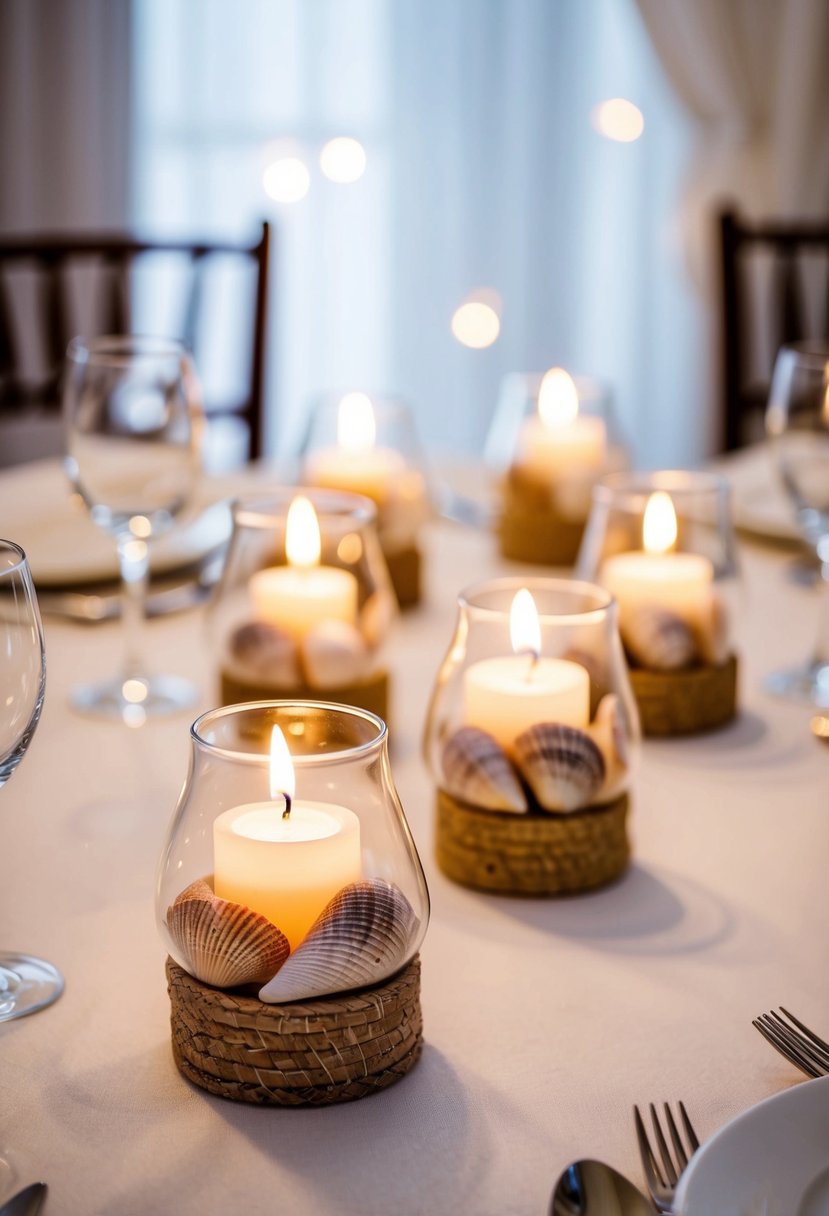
63,336 -> 201,726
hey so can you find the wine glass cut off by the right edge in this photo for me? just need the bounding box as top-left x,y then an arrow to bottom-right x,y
766,342 -> 829,708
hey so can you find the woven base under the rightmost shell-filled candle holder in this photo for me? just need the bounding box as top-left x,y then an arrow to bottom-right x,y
630,654 -> 738,737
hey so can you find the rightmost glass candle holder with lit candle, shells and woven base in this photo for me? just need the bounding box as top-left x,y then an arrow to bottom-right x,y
577,471 -> 739,736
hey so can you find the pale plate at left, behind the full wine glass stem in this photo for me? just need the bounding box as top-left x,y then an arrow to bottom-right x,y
0,460 -> 231,586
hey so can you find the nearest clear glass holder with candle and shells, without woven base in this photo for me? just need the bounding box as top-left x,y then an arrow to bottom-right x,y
156,702 -> 429,1004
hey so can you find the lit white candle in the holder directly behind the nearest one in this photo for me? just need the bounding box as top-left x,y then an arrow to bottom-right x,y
248,497 -> 357,642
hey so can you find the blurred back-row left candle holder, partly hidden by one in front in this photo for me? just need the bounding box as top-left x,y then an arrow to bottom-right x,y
300,392 -> 432,608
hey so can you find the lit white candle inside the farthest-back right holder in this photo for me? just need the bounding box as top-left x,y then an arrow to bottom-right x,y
518,367 -> 608,479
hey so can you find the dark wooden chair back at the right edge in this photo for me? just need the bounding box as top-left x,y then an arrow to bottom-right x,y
720,210 -> 829,451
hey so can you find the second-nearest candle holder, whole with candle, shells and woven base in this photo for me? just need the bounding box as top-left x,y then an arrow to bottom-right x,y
424,578 -> 639,895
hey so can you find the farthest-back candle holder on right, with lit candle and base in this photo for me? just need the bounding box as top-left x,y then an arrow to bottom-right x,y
486,367 -> 626,567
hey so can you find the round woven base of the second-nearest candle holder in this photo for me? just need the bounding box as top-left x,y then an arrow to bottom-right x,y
435,789 -> 631,895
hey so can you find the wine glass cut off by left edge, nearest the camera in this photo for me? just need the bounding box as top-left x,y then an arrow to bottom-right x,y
0,540 -> 63,1021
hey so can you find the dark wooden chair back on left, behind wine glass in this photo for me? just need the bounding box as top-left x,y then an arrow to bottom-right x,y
0,224 -> 271,465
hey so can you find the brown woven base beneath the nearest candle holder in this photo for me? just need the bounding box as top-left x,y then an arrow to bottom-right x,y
167,956 -> 423,1107
